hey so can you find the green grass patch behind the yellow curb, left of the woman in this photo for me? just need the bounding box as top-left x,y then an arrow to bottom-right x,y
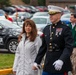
0,53 -> 14,69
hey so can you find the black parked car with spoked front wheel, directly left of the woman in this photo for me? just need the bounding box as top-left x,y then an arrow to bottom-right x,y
0,19 -> 21,53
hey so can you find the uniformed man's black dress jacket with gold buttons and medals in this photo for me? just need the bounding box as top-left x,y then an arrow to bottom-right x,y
35,21 -> 73,73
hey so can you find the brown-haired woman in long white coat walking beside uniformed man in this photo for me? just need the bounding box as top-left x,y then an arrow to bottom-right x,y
13,19 -> 42,75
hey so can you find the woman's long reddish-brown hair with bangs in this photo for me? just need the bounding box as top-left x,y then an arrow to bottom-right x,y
19,19 -> 37,41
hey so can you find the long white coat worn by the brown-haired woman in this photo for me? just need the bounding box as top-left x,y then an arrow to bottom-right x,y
13,34 -> 42,75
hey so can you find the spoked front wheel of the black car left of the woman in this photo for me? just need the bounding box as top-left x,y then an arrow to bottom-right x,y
7,39 -> 18,53
